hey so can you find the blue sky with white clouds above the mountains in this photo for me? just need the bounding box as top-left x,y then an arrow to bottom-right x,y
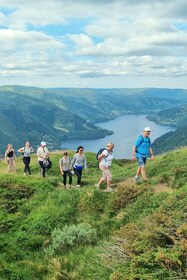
0,0 -> 187,88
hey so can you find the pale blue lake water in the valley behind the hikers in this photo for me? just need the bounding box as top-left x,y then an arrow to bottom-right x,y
61,115 -> 174,159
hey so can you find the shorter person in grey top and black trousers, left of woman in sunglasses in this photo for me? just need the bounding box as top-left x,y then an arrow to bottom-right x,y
59,151 -> 72,187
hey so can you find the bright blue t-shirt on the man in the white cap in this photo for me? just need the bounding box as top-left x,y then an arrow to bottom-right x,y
135,135 -> 151,157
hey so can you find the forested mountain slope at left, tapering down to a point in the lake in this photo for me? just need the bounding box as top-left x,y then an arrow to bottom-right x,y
0,88 -> 112,152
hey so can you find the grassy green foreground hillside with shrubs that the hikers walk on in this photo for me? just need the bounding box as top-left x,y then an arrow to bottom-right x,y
0,148 -> 187,280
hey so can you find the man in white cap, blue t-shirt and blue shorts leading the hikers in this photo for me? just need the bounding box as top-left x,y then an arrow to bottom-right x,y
132,127 -> 154,182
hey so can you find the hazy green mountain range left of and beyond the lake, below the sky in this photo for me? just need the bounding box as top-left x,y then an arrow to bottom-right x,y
0,86 -> 187,153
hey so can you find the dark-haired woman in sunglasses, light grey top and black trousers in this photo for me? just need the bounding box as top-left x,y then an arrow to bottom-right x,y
71,146 -> 87,188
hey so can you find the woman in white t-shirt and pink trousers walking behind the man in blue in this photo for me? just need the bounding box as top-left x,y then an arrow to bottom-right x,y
95,142 -> 114,192
